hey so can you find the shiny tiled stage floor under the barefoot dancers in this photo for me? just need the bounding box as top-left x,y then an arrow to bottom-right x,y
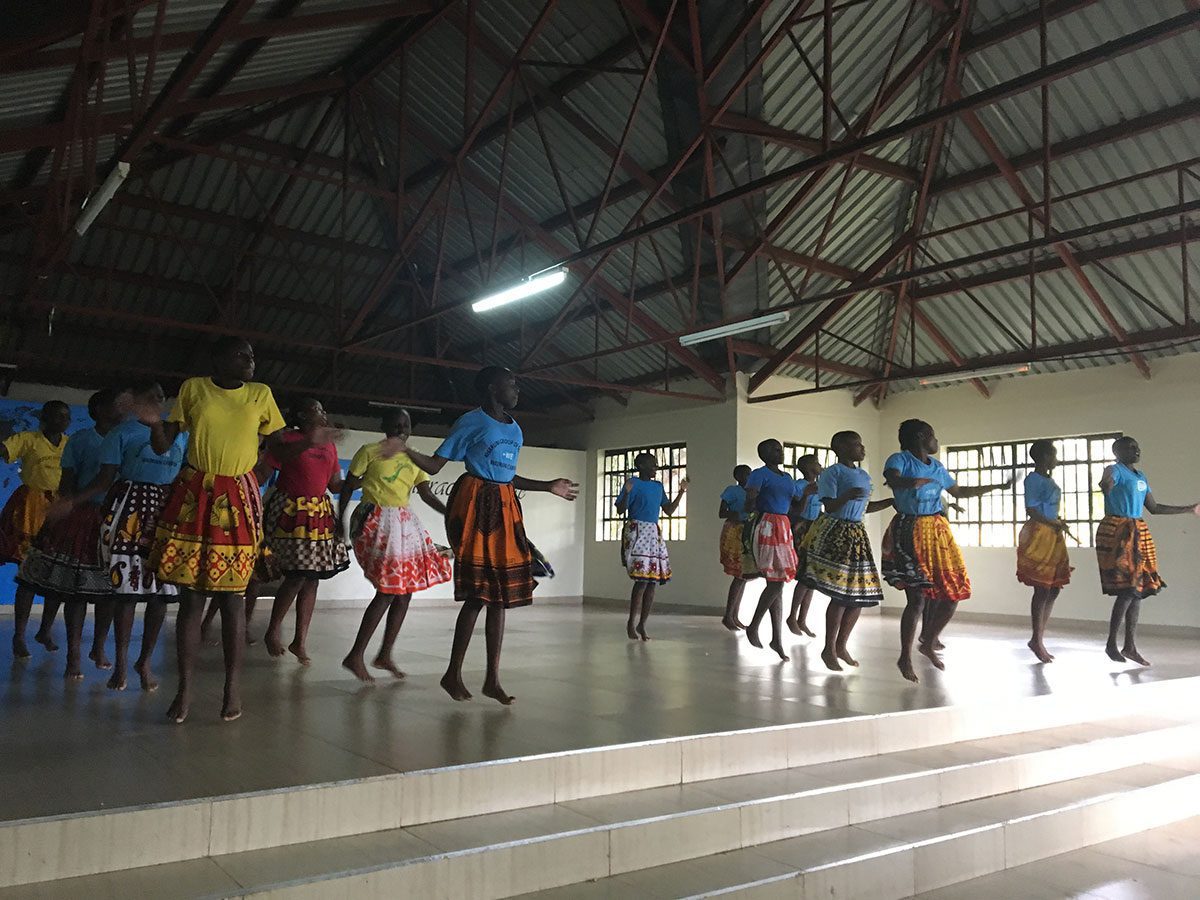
0,602 -> 1200,820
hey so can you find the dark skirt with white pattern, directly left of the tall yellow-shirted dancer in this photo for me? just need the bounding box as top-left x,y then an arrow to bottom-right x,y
100,481 -> 179,600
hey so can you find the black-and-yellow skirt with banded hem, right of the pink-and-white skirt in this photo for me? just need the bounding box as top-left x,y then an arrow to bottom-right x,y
802,515 -> 883,607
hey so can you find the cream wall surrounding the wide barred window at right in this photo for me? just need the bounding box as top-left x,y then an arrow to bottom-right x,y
880,355 -> 1200,626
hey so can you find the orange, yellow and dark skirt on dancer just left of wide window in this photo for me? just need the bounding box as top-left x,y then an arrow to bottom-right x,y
881,512 -> 971,602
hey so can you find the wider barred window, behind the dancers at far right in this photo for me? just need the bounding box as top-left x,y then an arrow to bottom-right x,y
942,432 -> 1121,547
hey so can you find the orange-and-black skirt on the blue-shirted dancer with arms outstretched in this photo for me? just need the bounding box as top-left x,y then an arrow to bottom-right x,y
446,473 -> 535,607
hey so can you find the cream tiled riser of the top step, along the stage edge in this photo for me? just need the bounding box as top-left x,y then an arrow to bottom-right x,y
0,678 -> 1200,886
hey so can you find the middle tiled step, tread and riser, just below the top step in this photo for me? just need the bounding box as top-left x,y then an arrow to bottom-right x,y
0,716 -> 1200,899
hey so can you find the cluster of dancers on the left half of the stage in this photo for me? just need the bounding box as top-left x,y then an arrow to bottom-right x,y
0,337 -> 578,722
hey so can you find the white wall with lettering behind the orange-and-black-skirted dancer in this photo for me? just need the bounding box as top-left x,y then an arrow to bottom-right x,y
318,431 -> 586,606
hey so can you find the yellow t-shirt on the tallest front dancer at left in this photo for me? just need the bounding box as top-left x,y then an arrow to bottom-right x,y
167,378 -> 284,476
